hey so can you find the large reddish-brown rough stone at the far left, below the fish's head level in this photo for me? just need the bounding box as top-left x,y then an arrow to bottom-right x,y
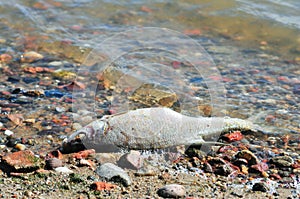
0,150 -> 43,173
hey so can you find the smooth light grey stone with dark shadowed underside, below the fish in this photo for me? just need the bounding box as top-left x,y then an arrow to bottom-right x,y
95,163 -> 131,187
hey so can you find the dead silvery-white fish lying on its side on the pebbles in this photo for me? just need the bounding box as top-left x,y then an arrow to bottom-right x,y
68,107 -> 255,150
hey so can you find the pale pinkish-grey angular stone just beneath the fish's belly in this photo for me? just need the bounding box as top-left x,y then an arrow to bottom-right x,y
118,150 -> 144,170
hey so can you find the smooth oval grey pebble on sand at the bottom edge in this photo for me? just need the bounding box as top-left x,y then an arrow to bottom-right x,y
157,184 -> 185,198
